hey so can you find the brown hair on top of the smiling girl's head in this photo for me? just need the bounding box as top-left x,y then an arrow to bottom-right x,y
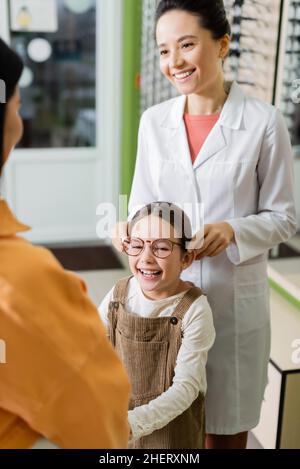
128,202 -> 192,251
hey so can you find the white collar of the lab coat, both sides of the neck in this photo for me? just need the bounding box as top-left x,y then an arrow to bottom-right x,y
161,82 -> 245,130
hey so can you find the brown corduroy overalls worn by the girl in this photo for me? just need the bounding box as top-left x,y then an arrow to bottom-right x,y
108,277 -> 205,449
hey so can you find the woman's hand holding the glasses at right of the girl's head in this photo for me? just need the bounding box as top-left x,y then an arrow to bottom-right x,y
190,222 -> 234,260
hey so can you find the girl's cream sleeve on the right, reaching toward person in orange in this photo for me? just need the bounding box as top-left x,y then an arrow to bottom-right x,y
128,297 -> 215,440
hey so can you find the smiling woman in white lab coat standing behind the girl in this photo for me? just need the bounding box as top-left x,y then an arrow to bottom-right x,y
129,0 -> 296,448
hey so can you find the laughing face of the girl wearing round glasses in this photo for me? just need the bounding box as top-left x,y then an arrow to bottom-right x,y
128,215 -> 194,300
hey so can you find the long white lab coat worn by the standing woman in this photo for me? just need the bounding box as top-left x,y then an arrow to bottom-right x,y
129,82 -> 296,434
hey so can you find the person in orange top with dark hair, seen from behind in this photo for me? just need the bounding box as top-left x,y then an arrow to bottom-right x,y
0,39 -> 129,449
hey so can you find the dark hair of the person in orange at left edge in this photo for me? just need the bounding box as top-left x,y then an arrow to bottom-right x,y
0,38 -> 23,174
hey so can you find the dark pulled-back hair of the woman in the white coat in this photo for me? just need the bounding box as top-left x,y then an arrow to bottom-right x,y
155,0 -> 231,39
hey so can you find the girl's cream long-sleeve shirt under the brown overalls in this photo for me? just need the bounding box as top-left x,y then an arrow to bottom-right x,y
99,277 -> 215,440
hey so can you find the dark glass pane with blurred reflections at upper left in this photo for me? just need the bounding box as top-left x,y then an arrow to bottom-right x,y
10,0 -> 96,148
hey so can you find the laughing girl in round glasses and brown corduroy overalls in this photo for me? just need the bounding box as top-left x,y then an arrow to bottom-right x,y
99,202 -> 215,449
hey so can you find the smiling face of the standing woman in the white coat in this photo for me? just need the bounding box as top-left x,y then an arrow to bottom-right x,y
156,10 -> 227,95
